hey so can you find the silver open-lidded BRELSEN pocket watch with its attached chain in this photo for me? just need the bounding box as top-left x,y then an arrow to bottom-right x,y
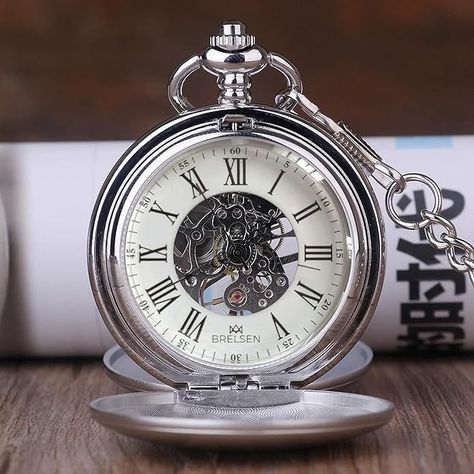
88,22 -> 474,447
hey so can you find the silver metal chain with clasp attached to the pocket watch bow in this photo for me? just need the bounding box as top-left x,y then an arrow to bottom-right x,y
275,88 -> 474,286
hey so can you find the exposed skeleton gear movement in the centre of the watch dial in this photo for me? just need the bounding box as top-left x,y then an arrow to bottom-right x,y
174,193 -> 298,315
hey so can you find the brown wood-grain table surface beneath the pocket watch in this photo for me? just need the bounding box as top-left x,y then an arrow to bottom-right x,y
0,356 -> 474,474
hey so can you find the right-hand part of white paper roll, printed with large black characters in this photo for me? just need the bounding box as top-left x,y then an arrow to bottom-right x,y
364,136 -> 474,352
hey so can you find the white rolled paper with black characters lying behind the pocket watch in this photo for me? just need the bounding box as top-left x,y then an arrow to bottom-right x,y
0,136 -> 474,356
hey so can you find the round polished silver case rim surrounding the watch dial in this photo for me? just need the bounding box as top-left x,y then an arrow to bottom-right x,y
88,105 -> 385,389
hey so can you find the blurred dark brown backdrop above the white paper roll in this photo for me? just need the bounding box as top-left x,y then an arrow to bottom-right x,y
0,0 -> 474,141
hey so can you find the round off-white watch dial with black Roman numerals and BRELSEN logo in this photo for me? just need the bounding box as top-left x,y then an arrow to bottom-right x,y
121,137 -> 354,368
